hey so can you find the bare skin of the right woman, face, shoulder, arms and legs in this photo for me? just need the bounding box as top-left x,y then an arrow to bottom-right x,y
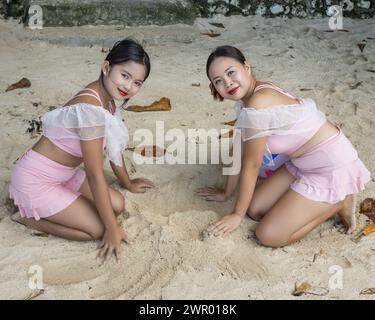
196,57 -> 355,247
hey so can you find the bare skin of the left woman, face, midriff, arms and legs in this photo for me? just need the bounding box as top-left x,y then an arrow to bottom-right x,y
15,61 -> 154,260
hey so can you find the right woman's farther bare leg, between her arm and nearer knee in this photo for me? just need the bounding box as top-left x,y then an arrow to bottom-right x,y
247,166 -> 295,221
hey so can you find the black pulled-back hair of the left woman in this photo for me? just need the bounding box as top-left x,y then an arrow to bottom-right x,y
105,38 -> 151,80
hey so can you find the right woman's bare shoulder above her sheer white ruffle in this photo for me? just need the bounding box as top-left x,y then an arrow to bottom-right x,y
246,88 -> 297,109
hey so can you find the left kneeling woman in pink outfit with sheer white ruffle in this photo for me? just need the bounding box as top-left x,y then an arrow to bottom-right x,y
9,39 -> 153,258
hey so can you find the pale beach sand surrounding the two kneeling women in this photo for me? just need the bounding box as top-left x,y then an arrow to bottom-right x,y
0,16 -> 375,299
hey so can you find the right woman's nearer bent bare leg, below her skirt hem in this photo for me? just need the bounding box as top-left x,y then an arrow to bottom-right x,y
256,190 -> 343,247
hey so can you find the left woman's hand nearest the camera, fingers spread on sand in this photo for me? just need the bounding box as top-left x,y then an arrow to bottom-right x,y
98,225 -> 132,261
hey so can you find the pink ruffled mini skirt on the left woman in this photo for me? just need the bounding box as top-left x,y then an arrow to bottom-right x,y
9,149 -> 86,220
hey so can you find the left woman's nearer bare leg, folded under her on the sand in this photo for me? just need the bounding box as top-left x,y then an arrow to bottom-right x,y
12,196 -> 104,241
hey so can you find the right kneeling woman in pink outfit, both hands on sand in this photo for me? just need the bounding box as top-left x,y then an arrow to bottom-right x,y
197,46 -> 371,247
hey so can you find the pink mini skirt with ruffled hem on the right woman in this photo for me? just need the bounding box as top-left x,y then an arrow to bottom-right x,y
285,130 -> 371,204
